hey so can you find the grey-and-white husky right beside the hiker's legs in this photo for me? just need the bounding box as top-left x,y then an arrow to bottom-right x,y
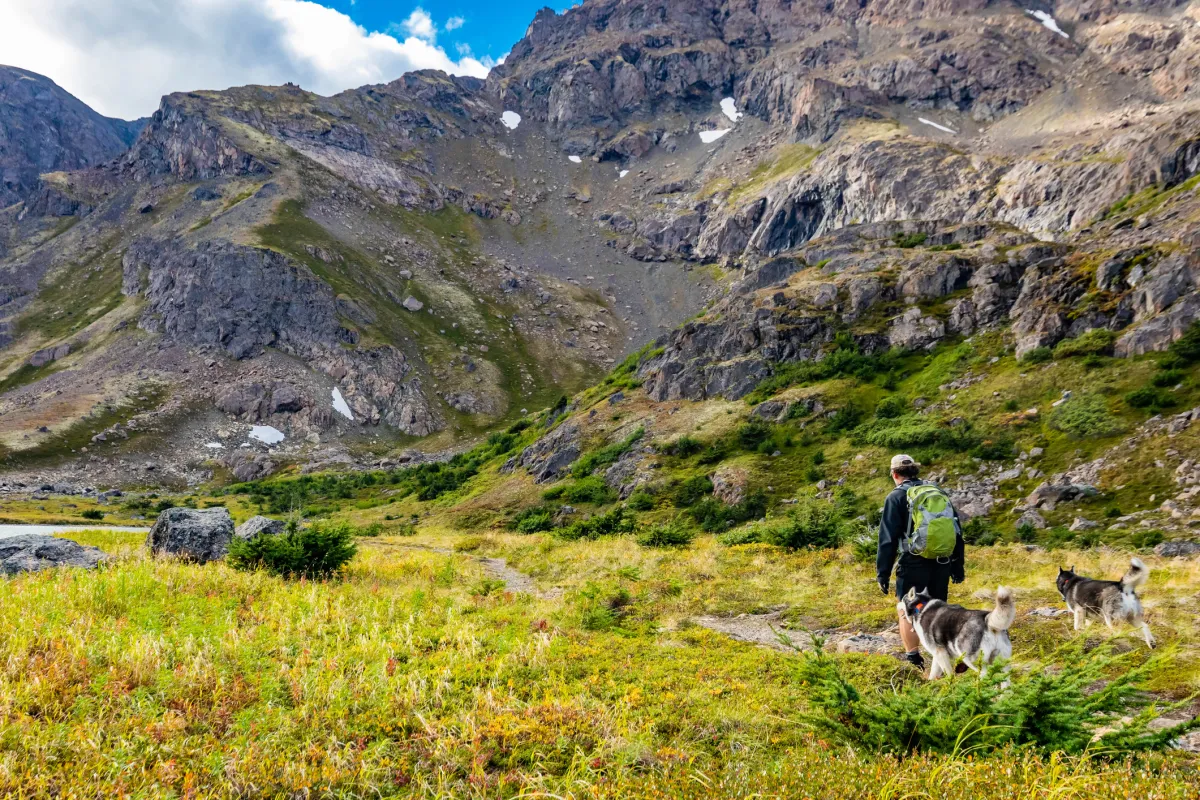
899,587 -> 1016,680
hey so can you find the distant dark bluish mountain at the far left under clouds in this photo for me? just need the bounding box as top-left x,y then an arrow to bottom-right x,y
0,65 -> 144,207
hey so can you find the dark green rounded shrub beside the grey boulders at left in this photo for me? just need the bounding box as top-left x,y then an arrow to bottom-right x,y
228,523 -> 358,578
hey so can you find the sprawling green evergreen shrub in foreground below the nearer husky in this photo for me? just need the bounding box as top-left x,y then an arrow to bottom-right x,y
798,640 -> 1200,758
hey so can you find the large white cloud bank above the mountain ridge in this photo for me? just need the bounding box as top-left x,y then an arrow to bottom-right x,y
0,0 -> 492,119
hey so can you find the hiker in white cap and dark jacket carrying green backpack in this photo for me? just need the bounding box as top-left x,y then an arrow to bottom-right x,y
875,455 -> 964,669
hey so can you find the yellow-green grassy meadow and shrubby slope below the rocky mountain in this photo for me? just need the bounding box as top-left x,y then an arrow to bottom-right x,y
0,336 -> 1200,798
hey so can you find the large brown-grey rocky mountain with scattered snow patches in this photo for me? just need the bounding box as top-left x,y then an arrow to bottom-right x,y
0,0 -> 1200,483
